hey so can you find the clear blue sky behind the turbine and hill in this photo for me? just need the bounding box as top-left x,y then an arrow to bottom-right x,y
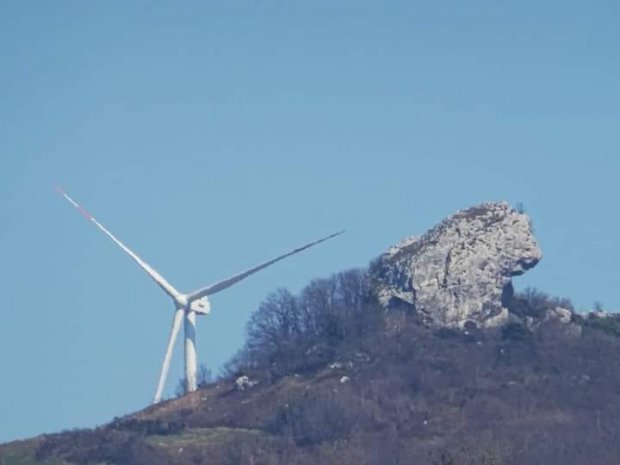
0,0 -> 620,441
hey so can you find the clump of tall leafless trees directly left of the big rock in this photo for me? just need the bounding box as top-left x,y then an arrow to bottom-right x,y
231,269 -> 384,378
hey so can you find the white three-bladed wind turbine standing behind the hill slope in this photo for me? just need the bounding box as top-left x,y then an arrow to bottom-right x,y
56,187 -> 344,404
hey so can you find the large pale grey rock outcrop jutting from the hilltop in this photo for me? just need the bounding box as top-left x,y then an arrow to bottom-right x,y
373,202 -> 542,327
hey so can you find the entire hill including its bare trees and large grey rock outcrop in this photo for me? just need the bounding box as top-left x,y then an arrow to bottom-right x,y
0,204 -> 620,465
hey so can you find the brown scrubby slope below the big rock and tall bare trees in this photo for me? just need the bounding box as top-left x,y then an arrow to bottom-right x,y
0,304 -> 620,465
